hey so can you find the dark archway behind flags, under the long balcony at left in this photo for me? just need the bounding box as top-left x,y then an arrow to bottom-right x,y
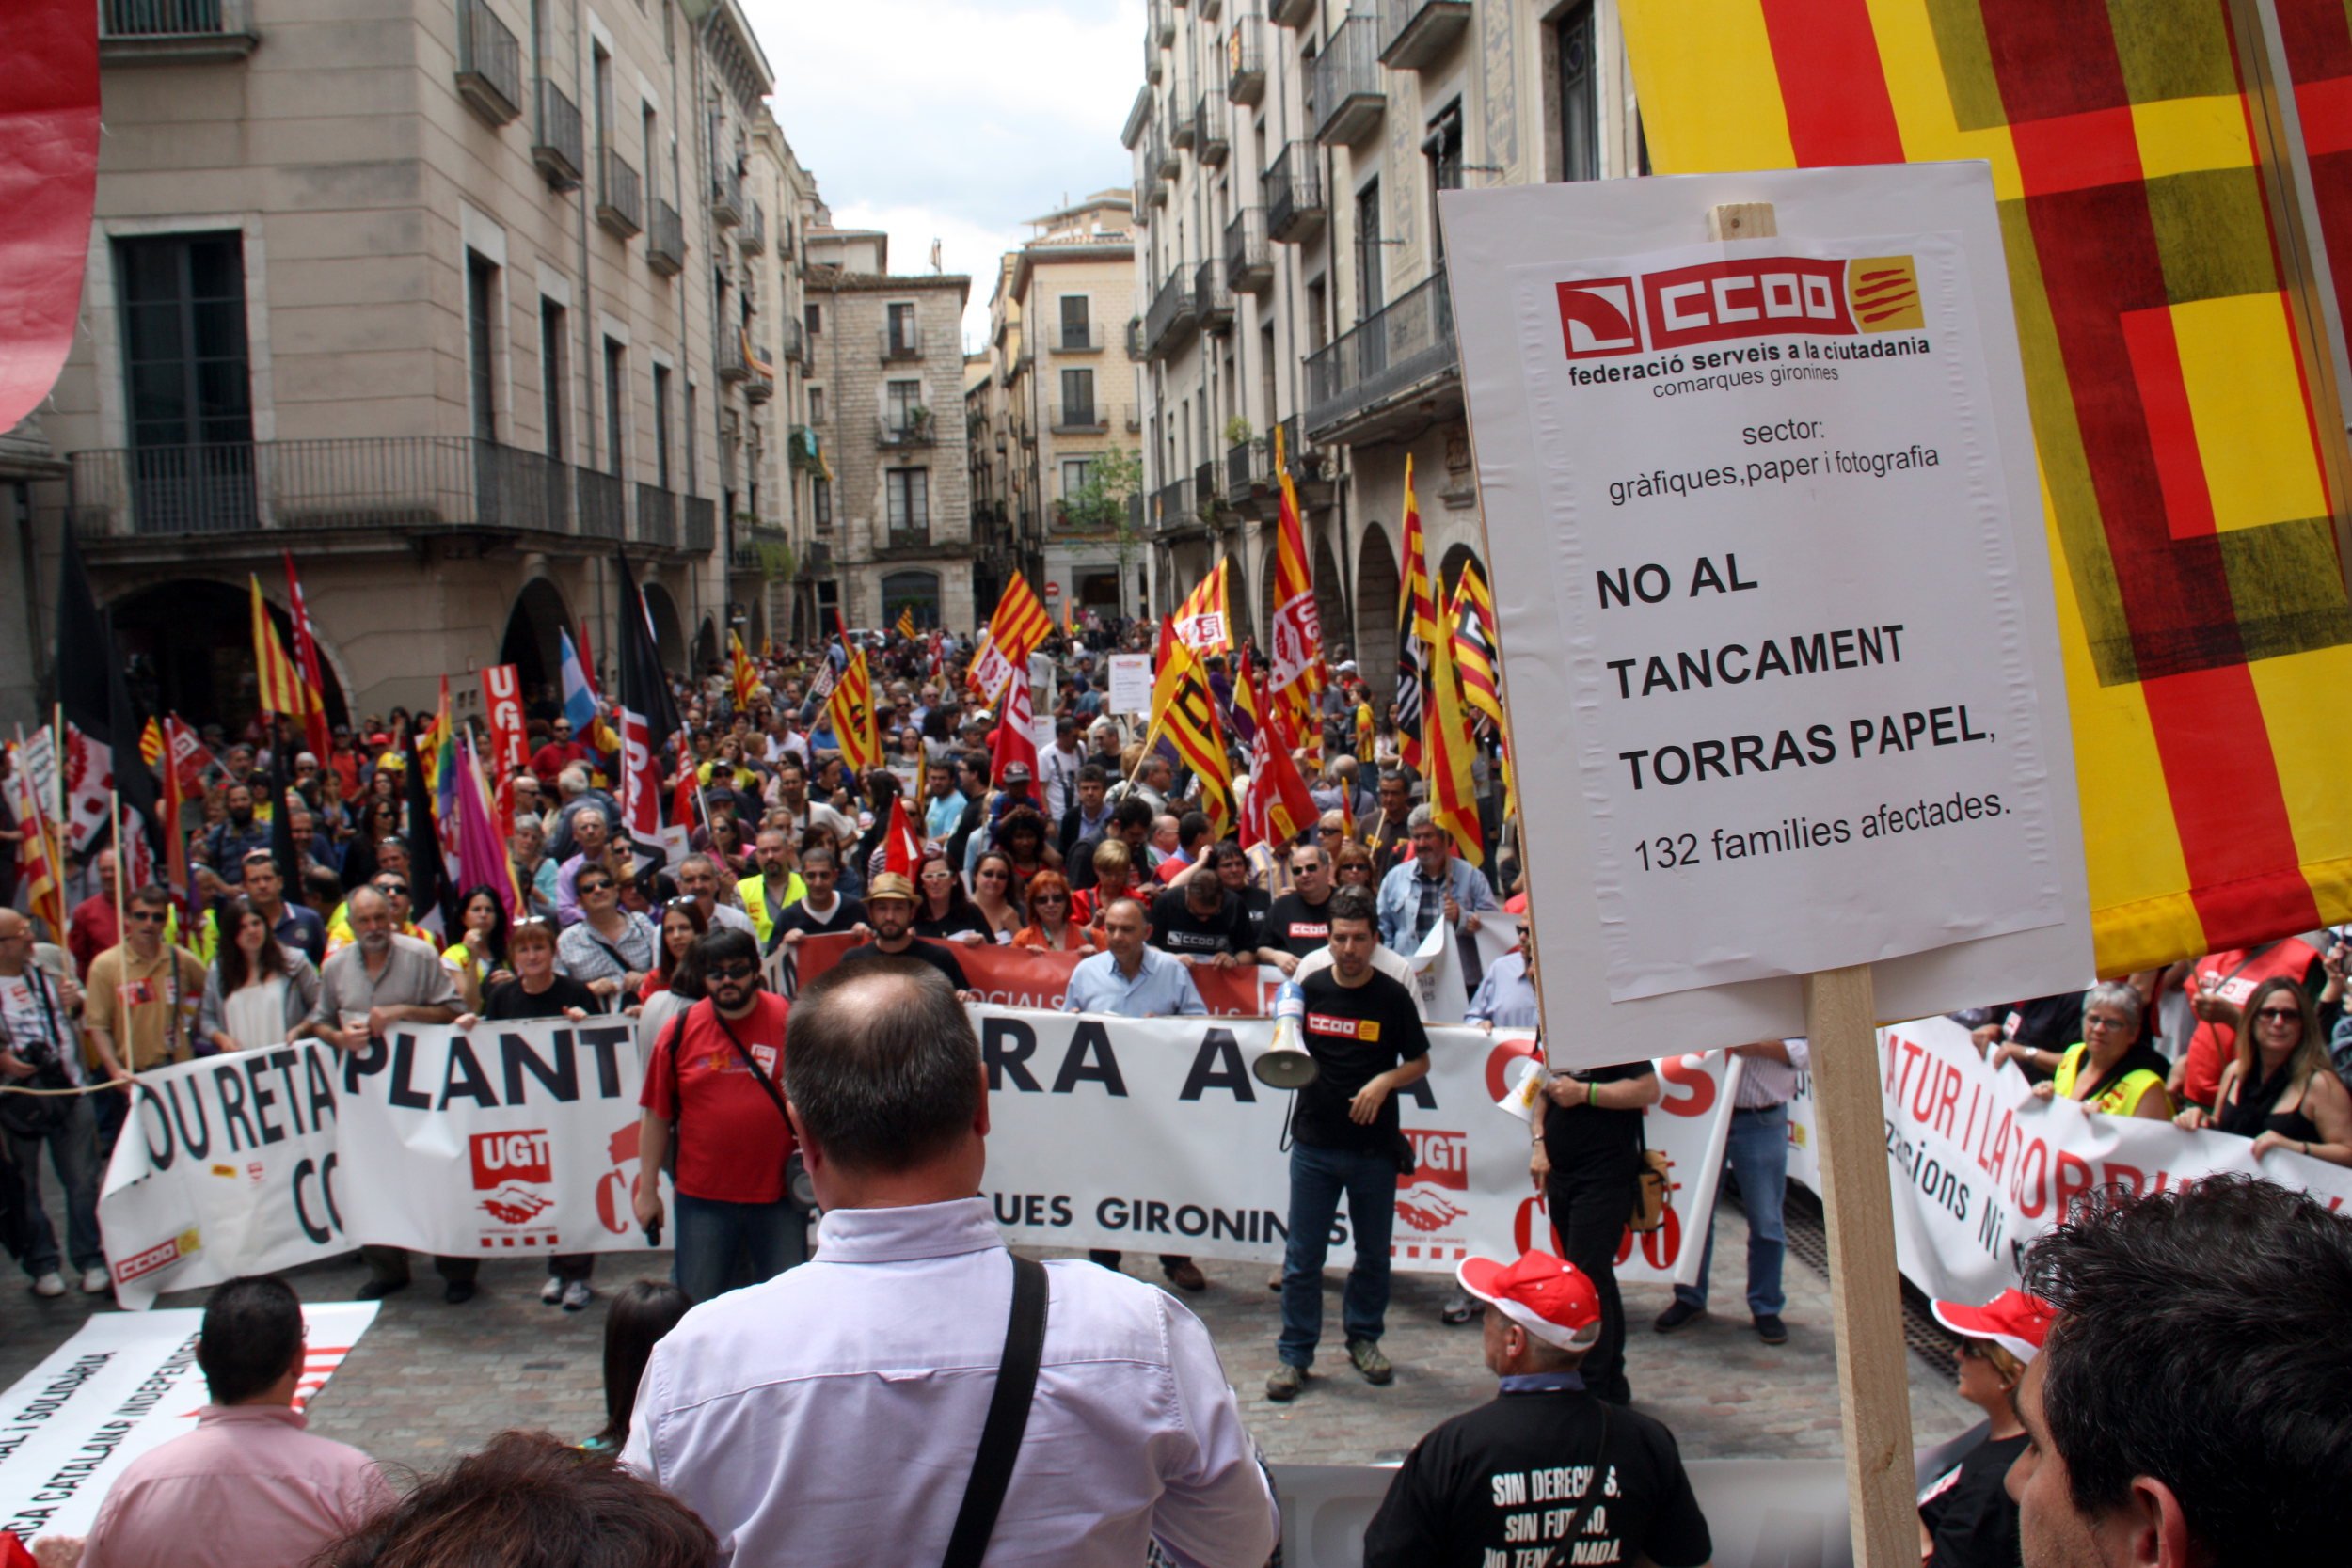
108,578 -> 351,736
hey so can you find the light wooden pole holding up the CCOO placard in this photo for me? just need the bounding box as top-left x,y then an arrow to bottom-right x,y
1804,964 -> 1919,1568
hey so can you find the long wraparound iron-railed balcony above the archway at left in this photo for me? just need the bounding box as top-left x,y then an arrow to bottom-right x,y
69,435 -> 720,547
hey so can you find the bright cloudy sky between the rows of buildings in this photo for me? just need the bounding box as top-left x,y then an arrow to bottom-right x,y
741,0 -> 1143,345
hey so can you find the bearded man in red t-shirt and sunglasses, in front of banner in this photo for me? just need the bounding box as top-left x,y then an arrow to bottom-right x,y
635,927 -> 809,1303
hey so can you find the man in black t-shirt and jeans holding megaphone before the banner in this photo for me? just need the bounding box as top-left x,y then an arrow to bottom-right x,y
1265,889 -> 1430,1402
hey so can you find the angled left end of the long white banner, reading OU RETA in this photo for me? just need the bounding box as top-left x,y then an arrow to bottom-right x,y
99,1044 -> 356,1312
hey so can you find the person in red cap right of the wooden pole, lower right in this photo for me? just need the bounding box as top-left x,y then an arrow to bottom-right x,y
1919,1291 -> 2051,1568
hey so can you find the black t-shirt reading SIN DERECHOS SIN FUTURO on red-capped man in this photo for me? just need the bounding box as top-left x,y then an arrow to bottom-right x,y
1364,1387 -> 1715,1568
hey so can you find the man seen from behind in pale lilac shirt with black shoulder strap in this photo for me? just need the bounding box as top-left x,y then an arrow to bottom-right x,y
621,957 -> 1275,1568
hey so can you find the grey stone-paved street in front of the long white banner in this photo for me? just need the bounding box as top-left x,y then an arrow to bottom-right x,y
0,1201 -> 1976,1479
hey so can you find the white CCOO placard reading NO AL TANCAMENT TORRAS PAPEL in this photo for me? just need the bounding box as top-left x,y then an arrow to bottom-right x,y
1442,165 -> 2091,1063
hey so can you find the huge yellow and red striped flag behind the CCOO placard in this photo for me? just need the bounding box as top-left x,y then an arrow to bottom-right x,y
1621,0 -> 2352,975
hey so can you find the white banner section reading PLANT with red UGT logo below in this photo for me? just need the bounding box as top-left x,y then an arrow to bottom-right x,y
337,1018 -> 663,1258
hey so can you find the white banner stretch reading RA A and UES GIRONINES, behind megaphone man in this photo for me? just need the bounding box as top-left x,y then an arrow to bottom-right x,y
972,1006 -> 1729,1281
